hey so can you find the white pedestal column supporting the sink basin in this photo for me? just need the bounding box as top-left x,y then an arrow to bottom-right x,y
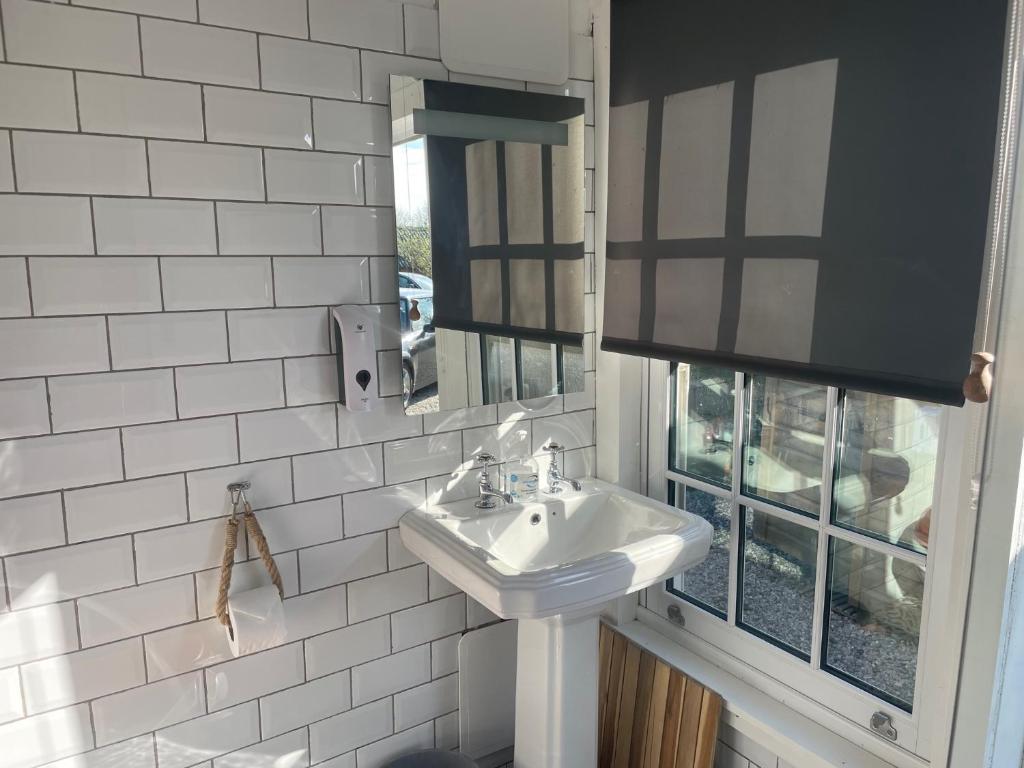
514,613 -> 599,768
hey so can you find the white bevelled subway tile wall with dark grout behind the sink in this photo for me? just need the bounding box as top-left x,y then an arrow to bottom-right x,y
0,0 -> 594,768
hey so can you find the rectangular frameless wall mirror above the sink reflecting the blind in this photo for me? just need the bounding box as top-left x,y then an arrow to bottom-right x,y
391,75 -> 585,414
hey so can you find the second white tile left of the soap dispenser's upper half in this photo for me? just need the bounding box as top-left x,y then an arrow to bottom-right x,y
110,312 -> 227,369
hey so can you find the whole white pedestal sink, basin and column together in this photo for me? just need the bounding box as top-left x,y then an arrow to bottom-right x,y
399,479 -> 712,768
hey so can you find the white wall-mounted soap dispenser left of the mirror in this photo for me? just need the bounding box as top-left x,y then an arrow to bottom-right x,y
331,304 -> 381,411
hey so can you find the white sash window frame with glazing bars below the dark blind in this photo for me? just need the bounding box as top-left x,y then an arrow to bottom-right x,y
638,360 -> 978,768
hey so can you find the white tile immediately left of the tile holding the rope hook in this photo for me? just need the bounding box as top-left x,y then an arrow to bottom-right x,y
65,475 -> 187,542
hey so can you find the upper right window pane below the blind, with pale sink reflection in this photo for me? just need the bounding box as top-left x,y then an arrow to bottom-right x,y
833,392 -> 941,552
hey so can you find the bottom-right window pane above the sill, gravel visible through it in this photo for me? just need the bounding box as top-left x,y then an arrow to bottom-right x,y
823,539 -> 925,712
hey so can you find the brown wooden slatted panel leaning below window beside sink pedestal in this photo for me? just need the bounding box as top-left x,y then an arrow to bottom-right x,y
598,626 -> 722,768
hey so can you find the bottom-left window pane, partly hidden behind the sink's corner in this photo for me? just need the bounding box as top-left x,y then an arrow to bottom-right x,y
676,484 -> 731,618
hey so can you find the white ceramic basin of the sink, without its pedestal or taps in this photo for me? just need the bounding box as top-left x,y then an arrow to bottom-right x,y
399,479 -> 712,618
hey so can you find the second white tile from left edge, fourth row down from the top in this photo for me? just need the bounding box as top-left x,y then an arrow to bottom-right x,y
92,198 -> 217,256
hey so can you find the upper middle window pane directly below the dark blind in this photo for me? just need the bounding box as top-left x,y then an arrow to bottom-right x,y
743,376 -> 828,515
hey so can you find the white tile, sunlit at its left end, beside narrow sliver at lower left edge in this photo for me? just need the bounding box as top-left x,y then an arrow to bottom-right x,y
22,637 -> 145,715
